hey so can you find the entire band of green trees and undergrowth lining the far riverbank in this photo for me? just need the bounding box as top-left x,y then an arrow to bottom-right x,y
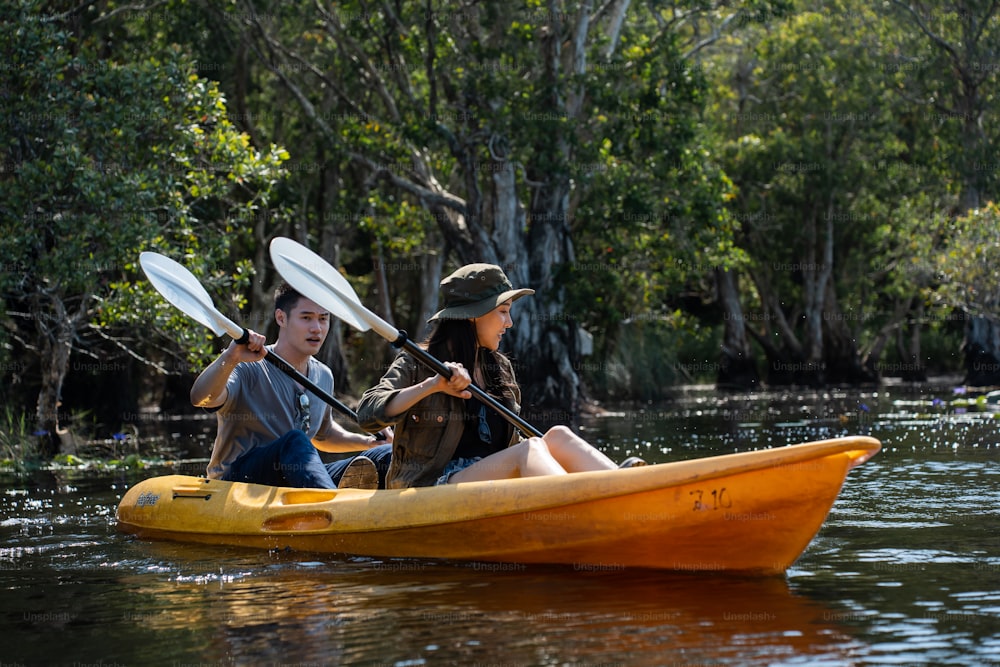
0,0 -> 1000,457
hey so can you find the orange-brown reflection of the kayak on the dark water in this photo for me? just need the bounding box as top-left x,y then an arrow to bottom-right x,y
107,547 -> 856,665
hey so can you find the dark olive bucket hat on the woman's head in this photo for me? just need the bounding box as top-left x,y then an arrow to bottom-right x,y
427,264 -> 535,322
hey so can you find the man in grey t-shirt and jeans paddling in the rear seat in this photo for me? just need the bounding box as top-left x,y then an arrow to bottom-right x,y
191,283 -> 392,489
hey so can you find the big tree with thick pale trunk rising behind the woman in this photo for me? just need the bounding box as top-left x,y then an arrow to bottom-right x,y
197,0 -> 752,421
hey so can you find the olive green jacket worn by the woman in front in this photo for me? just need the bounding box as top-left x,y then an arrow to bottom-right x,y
358,351 -> 521,489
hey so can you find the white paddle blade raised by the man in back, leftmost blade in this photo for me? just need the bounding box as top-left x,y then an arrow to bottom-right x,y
139,252 -> 243,338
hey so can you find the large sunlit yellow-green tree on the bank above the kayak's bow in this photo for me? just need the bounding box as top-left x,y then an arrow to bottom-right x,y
708,2 -> 947,385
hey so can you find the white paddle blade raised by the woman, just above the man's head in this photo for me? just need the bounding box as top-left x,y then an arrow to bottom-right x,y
271,236 -> 376,338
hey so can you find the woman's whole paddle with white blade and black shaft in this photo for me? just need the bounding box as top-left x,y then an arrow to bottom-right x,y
271,237 -> 542,436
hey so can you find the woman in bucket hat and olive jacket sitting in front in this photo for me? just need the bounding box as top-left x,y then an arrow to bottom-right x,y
358,264 -> 642,488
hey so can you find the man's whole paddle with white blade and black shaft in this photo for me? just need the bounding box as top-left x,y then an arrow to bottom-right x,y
139,252 -> 385,440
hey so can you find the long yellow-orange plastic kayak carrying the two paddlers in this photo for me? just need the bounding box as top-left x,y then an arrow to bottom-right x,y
118,436 -> 881,574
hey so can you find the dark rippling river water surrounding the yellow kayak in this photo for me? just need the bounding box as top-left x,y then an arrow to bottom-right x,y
0,387 -> 1000,667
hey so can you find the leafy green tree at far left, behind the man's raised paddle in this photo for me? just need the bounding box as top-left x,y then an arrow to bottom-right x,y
0,2 -> 283,455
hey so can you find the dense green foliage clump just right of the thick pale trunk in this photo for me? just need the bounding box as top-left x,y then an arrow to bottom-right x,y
564,3 -> 742,354
